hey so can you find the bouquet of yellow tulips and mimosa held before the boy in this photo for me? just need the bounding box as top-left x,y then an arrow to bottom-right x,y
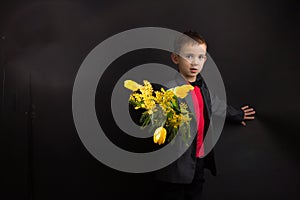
124,80 -> 194,145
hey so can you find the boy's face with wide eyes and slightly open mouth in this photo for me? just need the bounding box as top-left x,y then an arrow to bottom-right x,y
171,42 -> 206,82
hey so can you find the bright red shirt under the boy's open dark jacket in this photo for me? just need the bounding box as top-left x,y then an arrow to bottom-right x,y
192,86 -> 204,158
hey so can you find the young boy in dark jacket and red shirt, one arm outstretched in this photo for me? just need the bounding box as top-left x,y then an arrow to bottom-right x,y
155,31 -> 255,200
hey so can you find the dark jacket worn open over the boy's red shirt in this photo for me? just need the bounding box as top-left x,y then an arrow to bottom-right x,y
154,75 -> 243,183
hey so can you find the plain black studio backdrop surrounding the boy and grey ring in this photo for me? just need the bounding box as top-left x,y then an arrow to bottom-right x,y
0,0 -> 300,200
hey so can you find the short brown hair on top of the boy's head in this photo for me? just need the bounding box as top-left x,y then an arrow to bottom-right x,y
174,31 -> 207,54
